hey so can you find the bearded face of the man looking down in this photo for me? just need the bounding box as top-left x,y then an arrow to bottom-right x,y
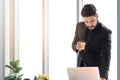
83,14 -> 98,30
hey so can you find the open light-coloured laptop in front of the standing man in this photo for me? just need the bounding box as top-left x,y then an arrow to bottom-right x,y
67,67 -> 100,80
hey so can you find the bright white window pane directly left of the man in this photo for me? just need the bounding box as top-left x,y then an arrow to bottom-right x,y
49,0 -> 77,80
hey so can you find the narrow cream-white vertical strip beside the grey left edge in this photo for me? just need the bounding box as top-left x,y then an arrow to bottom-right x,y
4,0 -> 10,76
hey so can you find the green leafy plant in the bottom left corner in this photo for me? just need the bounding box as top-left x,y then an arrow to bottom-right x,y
5,60 -> 23,80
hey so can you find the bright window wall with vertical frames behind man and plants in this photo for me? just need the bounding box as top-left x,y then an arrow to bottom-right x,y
0,0 -> 118,80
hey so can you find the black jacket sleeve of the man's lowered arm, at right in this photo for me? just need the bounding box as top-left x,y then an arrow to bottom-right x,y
100,30 -> 111,78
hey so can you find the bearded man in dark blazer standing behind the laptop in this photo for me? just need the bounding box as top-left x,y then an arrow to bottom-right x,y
72,4 -> 112,80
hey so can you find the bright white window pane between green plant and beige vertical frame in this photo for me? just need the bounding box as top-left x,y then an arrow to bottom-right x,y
19,0 -> 43,80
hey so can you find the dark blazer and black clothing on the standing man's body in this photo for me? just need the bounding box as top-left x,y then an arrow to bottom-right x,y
72,22 -> 111,78
